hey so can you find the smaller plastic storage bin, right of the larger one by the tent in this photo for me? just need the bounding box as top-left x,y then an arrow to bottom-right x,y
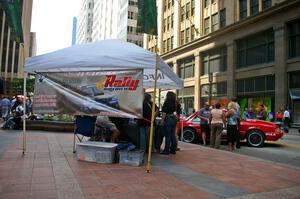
119,150 -> 144,166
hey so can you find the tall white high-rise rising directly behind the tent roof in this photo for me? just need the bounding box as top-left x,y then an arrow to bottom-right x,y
92,0 -> 143,46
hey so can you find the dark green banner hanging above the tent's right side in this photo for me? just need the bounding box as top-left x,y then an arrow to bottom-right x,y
137,0 -> 157,35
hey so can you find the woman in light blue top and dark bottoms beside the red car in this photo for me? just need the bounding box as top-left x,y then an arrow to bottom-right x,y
225,104 -> 239,151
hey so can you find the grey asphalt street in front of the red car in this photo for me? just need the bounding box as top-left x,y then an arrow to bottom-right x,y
218,129 -> 300,168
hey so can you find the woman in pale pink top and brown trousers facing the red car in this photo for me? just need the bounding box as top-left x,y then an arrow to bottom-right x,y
209,103 -> 225,149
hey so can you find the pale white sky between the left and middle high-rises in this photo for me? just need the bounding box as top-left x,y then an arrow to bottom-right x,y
31,0 -> 82,55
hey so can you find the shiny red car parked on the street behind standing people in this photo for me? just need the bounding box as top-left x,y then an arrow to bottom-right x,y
177,112 -> 284,147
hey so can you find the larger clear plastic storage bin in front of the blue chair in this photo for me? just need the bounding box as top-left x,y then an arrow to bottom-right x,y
77,141 -> 117,164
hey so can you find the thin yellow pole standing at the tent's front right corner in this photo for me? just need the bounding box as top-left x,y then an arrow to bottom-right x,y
147,36 -> 158,173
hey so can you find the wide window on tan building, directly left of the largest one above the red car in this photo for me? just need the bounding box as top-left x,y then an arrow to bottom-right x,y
201,46 -> 227,75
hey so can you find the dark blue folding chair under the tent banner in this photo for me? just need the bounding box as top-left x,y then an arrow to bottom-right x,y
73,116 -> 96,153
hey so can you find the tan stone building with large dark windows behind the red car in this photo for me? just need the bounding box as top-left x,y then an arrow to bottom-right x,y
144,0 -> 300,123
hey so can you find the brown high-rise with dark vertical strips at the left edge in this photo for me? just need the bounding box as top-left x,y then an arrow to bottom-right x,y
0,0 -> 36,95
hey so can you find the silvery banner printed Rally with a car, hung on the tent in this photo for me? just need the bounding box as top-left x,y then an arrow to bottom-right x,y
33,70 -> 143,118
